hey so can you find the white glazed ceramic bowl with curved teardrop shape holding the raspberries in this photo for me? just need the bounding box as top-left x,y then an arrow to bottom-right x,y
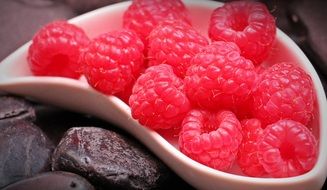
0,0 -> 327,190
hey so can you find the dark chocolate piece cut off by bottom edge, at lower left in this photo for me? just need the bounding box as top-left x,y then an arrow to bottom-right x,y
2,171 -> 94,190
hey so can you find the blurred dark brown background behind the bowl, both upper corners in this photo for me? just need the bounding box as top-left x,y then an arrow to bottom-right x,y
0,0 -> 327,189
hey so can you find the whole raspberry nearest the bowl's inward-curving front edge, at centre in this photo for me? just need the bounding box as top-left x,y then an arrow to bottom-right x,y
129,64 -> 190,129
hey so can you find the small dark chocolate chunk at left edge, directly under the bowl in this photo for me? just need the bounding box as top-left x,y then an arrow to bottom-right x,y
0,95 -> 35,123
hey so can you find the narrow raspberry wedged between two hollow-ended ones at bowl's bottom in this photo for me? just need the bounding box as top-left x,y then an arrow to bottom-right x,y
237,119 -> 266,177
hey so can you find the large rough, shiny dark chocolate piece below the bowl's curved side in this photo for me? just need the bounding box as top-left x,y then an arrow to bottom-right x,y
52,127 -> 169,189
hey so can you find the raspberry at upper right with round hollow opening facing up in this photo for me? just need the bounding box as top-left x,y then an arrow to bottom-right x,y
209,1 -> 276,64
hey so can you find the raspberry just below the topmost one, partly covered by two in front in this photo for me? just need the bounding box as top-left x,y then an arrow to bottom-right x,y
148,20 -> 208,78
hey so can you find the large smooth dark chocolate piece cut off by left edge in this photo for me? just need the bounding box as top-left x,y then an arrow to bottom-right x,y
0,120 -> 53,188
